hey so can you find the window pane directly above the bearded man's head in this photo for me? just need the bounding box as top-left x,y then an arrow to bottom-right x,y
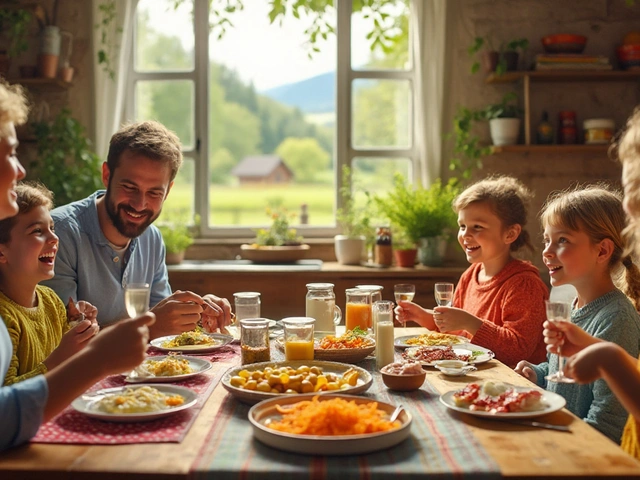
135,80 -> 194,150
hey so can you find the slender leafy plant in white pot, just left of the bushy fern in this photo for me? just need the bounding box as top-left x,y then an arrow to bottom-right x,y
334,165 -> 373,265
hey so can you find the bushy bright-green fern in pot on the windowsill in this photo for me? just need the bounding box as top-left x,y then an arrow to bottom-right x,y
374,174 -> 460,266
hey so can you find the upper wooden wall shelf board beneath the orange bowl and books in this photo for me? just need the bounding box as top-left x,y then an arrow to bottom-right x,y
485,69 -> 640,83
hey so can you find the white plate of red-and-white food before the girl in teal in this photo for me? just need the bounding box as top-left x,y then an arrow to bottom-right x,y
440,381 -> 566,418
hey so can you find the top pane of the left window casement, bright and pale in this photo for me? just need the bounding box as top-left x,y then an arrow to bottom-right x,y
135,0 -> 195,72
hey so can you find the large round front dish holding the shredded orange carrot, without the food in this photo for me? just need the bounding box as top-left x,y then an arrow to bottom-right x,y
249,394 -> 412,455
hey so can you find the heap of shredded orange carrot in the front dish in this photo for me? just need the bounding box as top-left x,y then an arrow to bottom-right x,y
265,396 -> 401,436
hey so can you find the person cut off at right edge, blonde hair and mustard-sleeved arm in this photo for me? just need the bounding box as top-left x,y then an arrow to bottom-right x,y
544,107 -> 640,459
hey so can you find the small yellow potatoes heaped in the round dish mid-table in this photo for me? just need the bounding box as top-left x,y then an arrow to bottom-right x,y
229,365 -> 359,393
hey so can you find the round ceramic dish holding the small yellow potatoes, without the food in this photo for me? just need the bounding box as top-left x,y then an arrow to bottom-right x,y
221,360 -> 373,404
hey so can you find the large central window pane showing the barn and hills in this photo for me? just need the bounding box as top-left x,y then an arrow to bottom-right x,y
209,0 -> 336,227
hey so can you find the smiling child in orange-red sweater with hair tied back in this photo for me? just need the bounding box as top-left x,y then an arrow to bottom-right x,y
396,176 -> 549,367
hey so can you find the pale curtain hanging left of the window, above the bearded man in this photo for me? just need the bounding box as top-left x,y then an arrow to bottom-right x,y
93,0 -> 136,160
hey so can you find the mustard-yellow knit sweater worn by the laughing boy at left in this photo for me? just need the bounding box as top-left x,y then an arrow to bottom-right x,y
0,285 -> 69,385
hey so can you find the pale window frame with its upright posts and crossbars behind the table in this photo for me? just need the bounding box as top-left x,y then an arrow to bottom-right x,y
123,0 -> 418,239
